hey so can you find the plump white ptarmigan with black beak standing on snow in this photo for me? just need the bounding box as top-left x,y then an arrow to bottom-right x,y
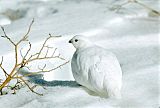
69,35 -> 122,98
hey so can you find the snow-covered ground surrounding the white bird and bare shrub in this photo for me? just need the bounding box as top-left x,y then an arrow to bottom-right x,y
0,0 -> 160,108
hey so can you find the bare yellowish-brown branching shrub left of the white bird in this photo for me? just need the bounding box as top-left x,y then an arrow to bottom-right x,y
0,19 -> 69,95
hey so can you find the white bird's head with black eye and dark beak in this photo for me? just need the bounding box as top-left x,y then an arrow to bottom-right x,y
69,35 -> 91,49
